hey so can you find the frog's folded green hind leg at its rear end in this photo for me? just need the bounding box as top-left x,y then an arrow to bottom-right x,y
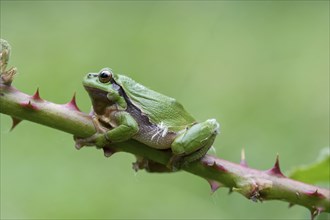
169,119 -> 220,168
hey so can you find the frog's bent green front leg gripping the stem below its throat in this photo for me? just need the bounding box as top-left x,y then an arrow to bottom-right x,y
76,111 -> 139,149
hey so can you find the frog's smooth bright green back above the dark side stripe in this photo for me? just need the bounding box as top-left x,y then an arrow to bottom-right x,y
114,74 -> 195,130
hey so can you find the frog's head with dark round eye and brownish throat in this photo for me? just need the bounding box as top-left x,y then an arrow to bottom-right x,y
83,68 -> 118,114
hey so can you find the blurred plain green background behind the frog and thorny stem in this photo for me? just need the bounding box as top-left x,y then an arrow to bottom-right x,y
0,0 -> 329,219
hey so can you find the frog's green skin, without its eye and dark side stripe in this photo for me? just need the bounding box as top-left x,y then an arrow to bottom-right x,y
83,68 -> 219,166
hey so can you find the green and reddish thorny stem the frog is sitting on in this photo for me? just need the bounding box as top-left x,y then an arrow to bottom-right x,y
0,39 -> 330,219
